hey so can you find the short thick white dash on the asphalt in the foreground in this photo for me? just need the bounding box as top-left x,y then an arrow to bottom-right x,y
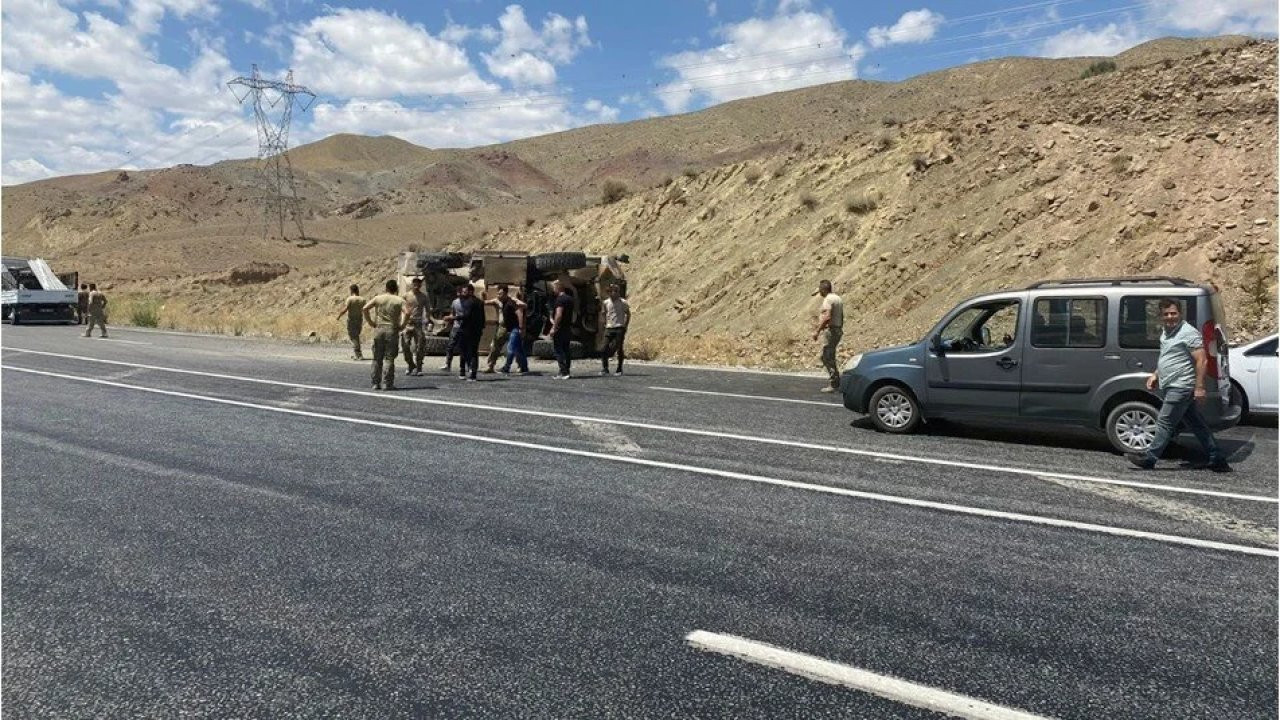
685,630 -> 1046,720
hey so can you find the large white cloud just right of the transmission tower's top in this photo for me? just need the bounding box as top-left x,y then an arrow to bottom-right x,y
293,9 -> 498,97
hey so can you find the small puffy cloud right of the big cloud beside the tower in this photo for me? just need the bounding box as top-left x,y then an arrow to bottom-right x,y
480,5 -> 591,86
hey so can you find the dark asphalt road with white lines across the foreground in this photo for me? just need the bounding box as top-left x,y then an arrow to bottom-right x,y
0,325 -> 1277,720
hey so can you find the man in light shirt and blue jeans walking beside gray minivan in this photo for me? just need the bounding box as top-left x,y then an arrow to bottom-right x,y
1125,297 -> 1231,473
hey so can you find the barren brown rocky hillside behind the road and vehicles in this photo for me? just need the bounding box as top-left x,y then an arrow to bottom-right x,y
4,37 -> 1276,365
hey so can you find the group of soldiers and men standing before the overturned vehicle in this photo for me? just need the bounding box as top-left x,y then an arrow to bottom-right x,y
338,278 -> 631,389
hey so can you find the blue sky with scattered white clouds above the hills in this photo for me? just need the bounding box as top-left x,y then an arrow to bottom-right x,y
0,0 -> 1276,184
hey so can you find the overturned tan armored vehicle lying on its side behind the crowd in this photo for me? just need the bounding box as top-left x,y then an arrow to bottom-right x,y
398,250 -> 628,357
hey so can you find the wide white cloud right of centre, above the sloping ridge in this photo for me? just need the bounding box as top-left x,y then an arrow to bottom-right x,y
655,0 -> 867,113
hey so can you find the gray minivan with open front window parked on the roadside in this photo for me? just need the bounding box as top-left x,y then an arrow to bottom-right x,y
840,277 -> 1240,452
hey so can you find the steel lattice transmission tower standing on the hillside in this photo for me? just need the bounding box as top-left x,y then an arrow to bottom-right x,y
227,65 -> 316,242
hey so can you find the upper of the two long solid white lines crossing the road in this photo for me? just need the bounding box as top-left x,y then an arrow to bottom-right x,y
5,348 -> 1280,505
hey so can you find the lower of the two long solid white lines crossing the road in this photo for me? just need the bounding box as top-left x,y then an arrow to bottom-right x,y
0,365 -> 1280,557
